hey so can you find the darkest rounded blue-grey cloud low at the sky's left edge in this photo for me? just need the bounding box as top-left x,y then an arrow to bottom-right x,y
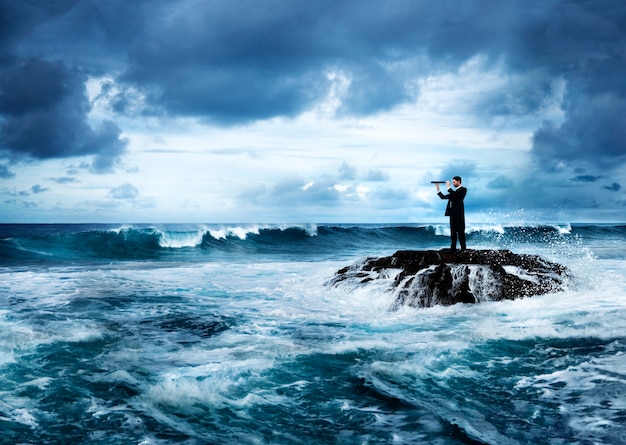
0,58 -> 128,173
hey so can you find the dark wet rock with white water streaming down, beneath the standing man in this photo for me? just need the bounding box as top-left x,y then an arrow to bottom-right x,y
327,250 -> 568,309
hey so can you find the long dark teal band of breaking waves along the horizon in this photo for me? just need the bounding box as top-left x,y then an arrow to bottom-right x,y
0,224 -> 626,262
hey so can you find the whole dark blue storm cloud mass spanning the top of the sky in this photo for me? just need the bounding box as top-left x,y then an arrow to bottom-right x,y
0,0 -> 626,173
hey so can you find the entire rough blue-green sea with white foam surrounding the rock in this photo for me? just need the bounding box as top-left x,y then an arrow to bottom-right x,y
0,223 -> 626,445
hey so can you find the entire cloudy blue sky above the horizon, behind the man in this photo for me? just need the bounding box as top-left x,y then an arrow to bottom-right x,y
0,0 -> 626,223
